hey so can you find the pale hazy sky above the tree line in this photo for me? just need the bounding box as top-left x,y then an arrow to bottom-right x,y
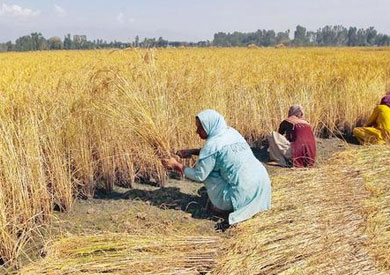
0,0 -> 390,42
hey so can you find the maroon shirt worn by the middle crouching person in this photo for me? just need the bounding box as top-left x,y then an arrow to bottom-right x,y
279,120 -> 316,167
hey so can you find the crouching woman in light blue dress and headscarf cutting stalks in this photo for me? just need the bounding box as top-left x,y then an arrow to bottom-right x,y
164,110 -> 271,225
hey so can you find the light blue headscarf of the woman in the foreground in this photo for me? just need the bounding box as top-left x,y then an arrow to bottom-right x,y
197,109 -> 246,160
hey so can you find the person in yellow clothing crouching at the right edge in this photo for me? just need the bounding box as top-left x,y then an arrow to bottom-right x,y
353,95 -> 390,144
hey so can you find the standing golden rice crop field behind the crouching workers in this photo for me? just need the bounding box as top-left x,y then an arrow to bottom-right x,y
0,48 -> 390,268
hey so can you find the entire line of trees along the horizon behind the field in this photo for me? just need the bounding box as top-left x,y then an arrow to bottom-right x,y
0,25 -> 390,51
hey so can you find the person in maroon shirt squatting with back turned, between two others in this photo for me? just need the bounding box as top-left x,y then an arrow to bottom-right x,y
268,105 -> 316,167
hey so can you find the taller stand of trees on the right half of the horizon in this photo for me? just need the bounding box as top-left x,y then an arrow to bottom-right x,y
213,25 -> 390,47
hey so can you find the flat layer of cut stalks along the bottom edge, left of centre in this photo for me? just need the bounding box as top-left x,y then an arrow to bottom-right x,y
21,234 -> 220,274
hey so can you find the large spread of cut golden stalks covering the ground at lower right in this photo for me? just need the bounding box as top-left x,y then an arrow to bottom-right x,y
213,146 -> 390,274
